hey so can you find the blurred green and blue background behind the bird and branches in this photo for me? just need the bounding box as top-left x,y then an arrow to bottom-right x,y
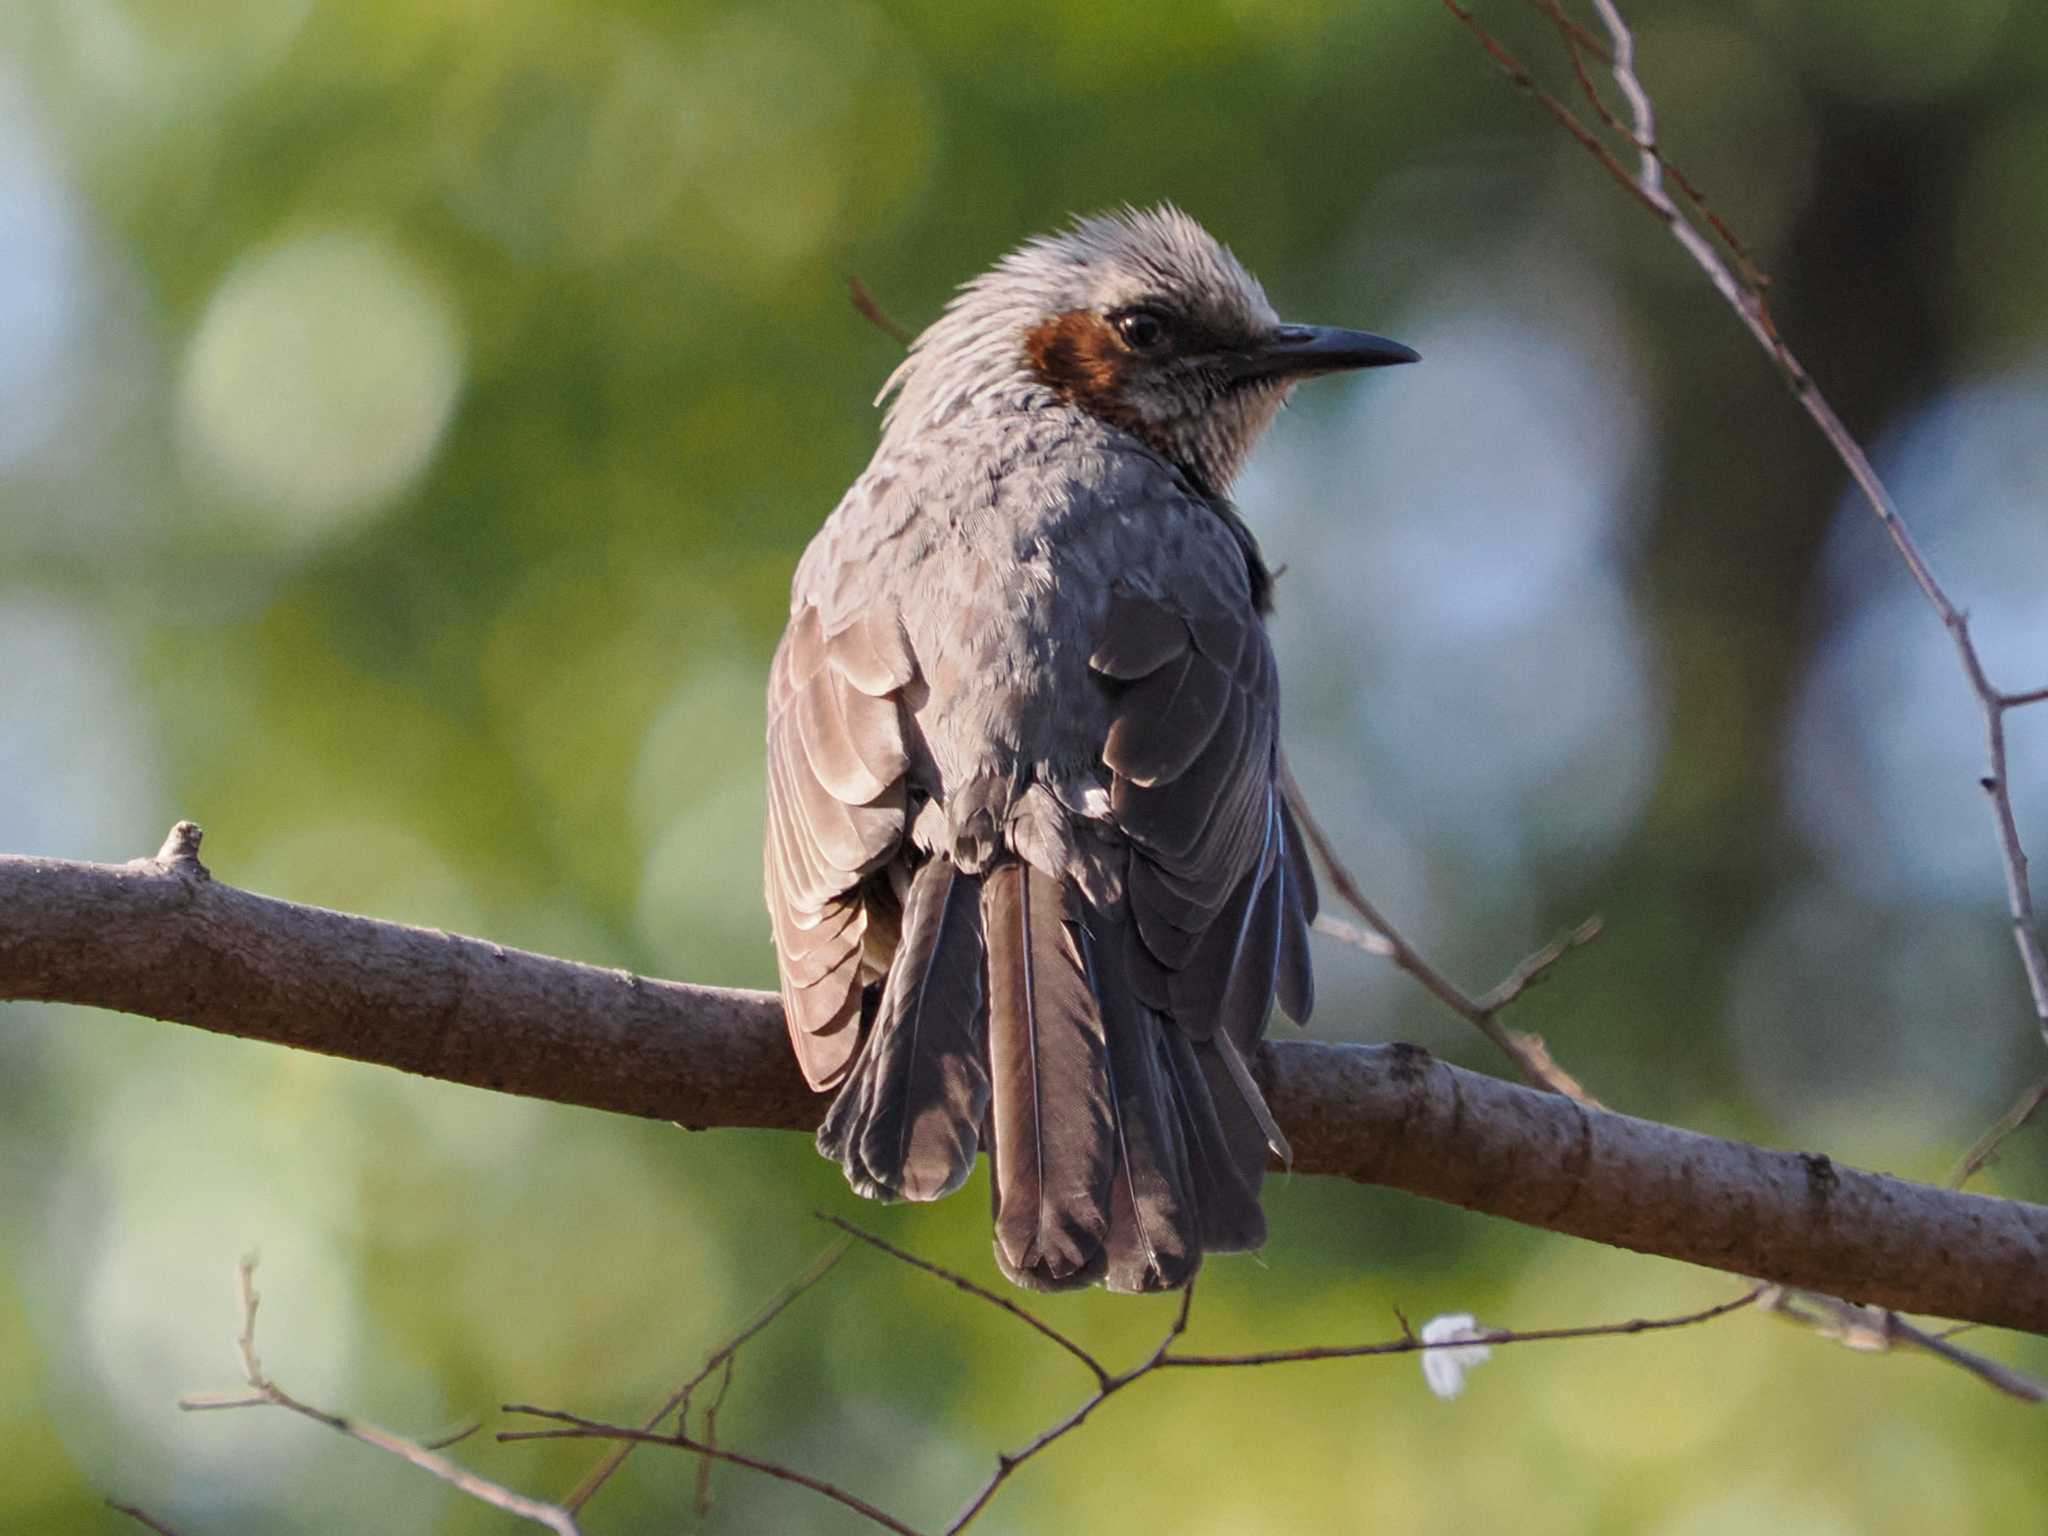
0,0 -> 2048,1536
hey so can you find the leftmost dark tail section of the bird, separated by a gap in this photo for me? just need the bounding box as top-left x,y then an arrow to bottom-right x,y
817,858 -> 989,1200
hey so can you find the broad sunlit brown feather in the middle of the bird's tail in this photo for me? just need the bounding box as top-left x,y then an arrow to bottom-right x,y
981,862 -> 1116,1290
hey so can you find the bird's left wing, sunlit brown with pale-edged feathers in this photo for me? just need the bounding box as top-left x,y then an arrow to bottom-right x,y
766,606 -> 915,1090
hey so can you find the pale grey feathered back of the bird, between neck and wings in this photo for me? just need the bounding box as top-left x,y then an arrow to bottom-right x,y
793,410 -> 1245,835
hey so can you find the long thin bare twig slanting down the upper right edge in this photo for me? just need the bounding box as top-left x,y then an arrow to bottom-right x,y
1442,0 -> 2048,1157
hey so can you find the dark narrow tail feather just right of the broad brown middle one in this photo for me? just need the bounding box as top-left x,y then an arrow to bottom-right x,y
1079,930 -> 1202,1290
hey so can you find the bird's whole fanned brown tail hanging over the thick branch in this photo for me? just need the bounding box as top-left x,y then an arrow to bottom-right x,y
817,858 -> 1272,1290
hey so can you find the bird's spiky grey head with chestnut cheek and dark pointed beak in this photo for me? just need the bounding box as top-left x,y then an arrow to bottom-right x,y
883,205 -> 1415,494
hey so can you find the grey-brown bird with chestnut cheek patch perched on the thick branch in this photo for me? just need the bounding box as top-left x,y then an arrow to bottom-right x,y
766,207 -> 1415,1290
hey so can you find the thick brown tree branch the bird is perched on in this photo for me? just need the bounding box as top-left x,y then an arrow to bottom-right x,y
0,823 -> 2048,1333
